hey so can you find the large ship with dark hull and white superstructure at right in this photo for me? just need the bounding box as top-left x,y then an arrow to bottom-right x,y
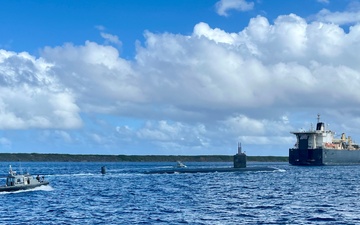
289,115 -> 360,166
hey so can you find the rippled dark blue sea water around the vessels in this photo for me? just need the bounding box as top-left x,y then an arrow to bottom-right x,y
0,163 -> 360,224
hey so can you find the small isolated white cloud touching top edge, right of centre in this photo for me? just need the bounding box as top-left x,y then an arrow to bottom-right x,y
215,0 -> 254,16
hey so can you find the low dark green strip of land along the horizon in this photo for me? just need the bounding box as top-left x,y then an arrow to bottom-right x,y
0,153 -> 288,162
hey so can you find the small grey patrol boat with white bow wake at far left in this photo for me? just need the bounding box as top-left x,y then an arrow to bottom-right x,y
0,165 -> 49,192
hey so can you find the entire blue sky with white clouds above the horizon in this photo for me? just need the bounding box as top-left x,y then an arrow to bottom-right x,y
0,0 -> 360,156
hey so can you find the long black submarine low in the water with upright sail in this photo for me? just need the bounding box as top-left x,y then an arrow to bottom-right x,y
145,143 -> 278,174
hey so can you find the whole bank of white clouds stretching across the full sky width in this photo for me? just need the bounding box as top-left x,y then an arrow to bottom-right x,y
0,10 -> 360,154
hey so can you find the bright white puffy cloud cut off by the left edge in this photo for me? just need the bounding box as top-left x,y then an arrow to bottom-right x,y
0,50 -> 81,129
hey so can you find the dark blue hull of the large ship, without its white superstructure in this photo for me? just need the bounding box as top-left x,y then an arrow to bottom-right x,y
289,148 -> 360,166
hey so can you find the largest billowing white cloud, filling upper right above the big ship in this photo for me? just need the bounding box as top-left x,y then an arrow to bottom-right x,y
137,14 -> 359,114
